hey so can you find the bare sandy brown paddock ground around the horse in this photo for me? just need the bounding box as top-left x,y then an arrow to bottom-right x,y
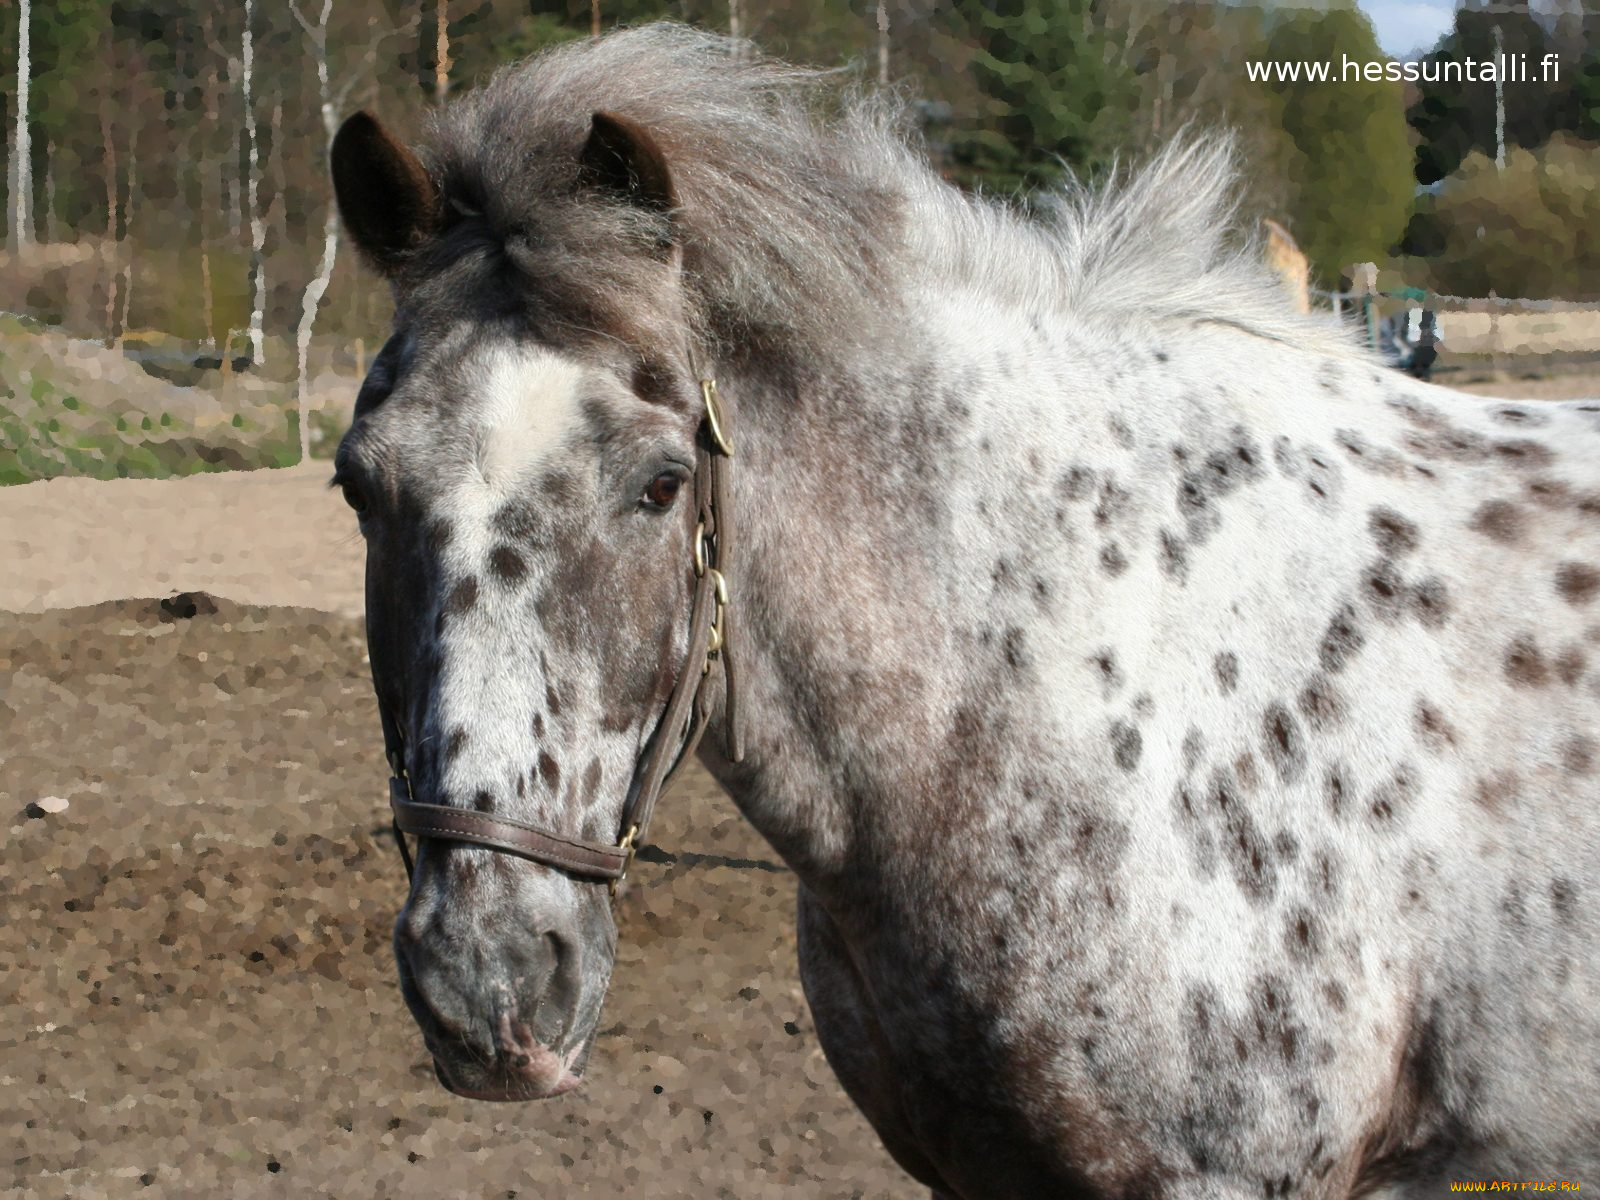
0,376 -> 1600,1200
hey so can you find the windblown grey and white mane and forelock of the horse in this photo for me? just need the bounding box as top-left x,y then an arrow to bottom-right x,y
424,22 -> 1349,361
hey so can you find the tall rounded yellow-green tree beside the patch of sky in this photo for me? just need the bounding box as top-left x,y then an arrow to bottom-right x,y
1261,6 -> 1414,280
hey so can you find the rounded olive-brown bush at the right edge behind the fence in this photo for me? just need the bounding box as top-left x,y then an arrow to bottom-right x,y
1426,136 -> 1600,299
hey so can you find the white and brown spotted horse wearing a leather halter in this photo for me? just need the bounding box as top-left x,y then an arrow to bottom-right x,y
331,26 -> 1600,1200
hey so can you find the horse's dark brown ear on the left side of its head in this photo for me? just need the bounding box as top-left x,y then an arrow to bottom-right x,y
331,112 -> 443,275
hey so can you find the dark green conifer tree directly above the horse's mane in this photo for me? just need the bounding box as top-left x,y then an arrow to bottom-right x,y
950,0 -> 1136,194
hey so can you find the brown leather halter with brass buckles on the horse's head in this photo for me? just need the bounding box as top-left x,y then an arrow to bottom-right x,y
378,379 -> 744,896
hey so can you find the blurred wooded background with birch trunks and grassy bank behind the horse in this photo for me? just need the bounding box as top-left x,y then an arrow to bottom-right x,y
0,0 -> 1600,483
